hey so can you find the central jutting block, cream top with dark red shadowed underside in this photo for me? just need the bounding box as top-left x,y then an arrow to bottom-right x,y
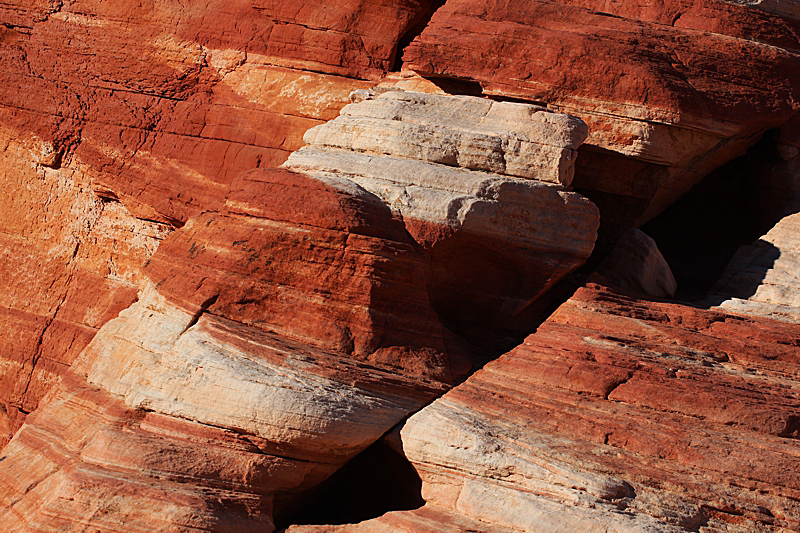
284,91 -> 599,344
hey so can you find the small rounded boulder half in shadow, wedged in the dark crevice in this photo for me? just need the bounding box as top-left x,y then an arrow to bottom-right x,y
594,228 -> 678,298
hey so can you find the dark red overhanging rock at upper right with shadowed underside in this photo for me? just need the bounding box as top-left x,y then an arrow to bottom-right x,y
403,0 -> 800,236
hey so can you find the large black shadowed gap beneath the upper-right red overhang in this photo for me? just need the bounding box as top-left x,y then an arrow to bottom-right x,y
641,132 -> 792,302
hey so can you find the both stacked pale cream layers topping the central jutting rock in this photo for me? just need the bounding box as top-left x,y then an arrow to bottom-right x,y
284,91 -> 599,258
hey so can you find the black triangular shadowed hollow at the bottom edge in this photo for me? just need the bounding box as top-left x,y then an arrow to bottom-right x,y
275,439 -> 425,529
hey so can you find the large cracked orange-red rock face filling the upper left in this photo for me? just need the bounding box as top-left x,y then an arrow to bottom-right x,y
0,0 -> 438,440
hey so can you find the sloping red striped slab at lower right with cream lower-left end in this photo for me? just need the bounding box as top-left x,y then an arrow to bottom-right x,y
296,285 -> 800,532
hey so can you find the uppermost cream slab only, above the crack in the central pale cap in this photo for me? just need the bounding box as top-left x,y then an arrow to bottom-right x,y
290,90 -> 589,186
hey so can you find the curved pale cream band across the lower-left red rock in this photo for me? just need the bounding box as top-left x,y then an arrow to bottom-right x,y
74,278 -> 442,461
